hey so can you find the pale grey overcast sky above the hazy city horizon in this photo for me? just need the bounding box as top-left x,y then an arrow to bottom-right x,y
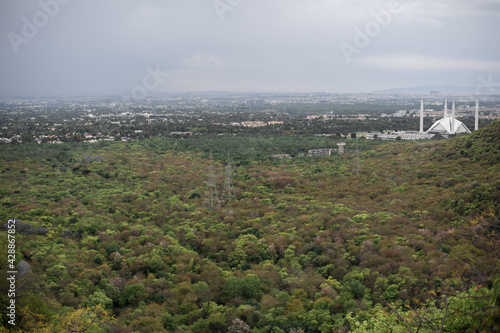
0,0 -> 500,95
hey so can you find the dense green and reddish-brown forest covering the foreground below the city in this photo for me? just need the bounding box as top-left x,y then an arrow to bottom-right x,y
0,121 -> 500,333
